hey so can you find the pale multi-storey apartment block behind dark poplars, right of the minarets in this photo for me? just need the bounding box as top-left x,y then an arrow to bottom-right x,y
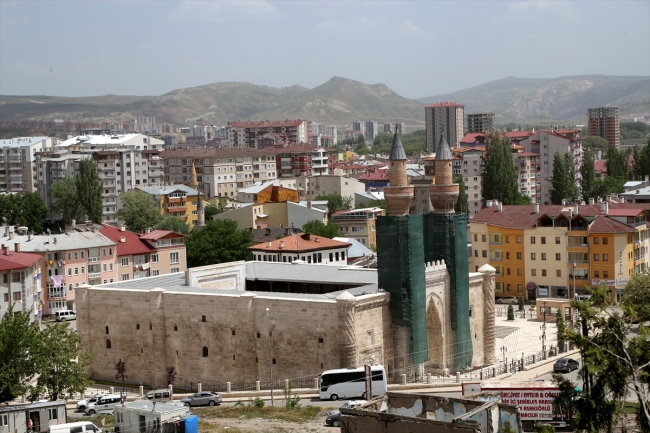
518,130 -> 583,203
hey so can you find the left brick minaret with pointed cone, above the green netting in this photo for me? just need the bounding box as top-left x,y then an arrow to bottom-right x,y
384,130 -> 414,216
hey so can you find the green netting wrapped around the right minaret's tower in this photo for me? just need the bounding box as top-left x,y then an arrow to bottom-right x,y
423,213 -> 473,369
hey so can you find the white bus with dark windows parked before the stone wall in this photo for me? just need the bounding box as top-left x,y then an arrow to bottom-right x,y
320,365 -> 387,400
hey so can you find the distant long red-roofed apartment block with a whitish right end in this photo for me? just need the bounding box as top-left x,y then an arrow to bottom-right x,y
228,119 -> 311,148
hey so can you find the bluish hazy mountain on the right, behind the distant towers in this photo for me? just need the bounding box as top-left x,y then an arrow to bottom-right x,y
418,75 -> 650,123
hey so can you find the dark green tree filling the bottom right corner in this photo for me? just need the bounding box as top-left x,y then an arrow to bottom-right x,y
567,280 -> 650,432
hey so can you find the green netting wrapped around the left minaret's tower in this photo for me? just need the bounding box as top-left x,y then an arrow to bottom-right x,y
377,215 -> 429,364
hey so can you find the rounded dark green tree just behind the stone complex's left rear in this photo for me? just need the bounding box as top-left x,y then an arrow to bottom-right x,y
185,219 -> 253,268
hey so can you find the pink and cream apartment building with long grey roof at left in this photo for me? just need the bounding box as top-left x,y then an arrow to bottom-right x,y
0,225 -> 116,315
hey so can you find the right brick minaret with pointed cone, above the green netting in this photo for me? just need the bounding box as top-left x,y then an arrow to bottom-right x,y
429,133 -> 459,214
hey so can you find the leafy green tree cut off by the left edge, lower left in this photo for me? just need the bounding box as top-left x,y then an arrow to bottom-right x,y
0,304 -> 42,403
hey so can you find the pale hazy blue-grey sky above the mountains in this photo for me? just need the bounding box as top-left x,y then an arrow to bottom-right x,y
0,0 -> 650,98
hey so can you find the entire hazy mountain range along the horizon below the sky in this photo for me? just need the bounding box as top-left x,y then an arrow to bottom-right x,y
0,75 -> 650,127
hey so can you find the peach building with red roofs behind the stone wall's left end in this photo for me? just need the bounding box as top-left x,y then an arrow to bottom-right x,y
99,224 -> 187,281
